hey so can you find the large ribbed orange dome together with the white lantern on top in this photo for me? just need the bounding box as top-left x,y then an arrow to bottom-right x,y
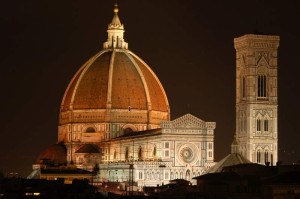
60,5 -> 170,125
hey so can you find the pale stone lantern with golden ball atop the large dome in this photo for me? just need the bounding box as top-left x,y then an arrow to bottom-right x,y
103,3 -> 128,49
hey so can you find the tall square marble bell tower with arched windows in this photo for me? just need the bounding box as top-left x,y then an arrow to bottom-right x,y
234,34 -> 279,165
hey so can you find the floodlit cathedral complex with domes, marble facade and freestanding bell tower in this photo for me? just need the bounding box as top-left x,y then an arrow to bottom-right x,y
29,2 -> 279,187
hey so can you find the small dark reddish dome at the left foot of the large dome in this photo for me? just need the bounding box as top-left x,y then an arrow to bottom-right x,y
36,143 -> 67,164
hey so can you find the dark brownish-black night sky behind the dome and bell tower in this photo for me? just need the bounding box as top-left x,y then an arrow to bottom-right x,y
0,0 -> 300,177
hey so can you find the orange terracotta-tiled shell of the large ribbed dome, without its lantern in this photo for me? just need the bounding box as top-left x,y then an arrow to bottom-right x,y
60,49 -> 170,124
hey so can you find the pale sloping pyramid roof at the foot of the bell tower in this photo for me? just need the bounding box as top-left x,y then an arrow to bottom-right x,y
206,153 -> 251,173
